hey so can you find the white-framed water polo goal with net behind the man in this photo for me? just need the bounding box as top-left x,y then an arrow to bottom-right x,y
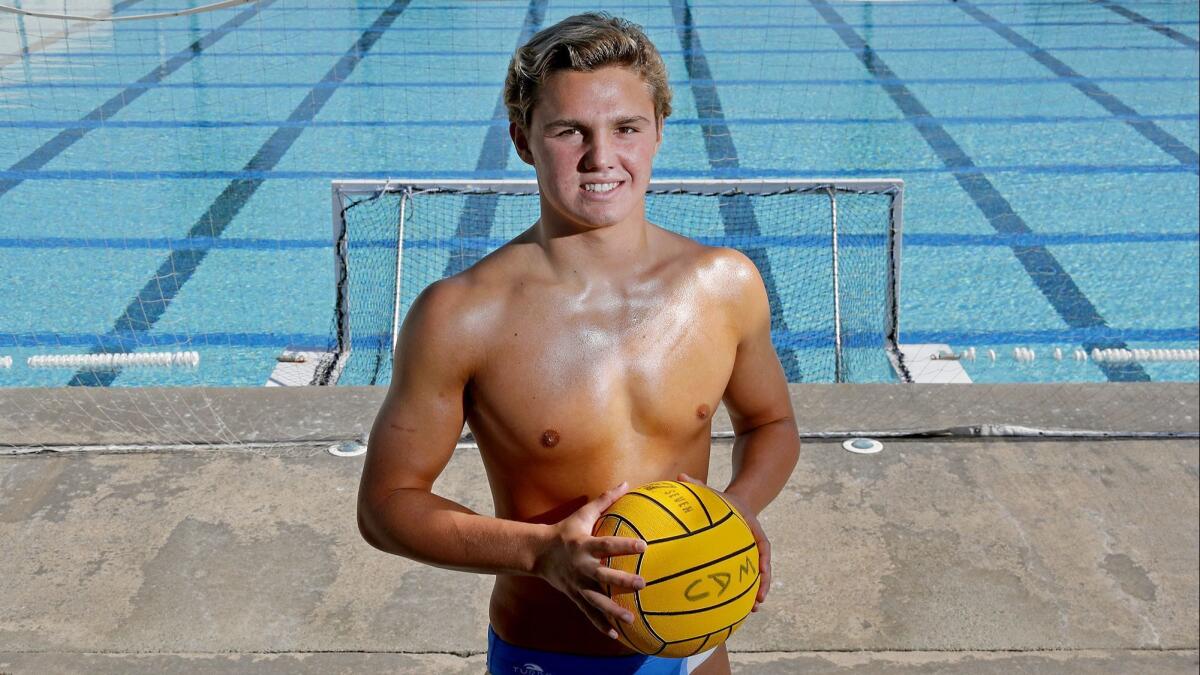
314,180 -> 907,384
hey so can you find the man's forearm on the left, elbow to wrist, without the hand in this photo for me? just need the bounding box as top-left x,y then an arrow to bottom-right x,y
359,489 -> 551,574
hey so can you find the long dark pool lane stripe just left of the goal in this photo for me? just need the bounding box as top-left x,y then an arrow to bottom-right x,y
67,0 -> 409,387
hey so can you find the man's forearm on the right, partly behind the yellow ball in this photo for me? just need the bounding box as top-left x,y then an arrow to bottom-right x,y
725,417 -> 800,515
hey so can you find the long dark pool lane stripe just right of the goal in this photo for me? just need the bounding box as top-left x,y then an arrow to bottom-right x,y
809,0 -> 1150,382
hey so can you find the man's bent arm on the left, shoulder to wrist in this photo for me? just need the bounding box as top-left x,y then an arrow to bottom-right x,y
358,280 -> 551,574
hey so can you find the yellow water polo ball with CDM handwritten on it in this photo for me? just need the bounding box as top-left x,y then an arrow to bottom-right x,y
593,480 -> 760,658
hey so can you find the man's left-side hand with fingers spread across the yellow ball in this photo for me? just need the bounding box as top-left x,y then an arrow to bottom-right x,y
534,483 -> 646,639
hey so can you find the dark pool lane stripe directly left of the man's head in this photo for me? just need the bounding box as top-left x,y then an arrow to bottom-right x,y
442,0 -> 547,276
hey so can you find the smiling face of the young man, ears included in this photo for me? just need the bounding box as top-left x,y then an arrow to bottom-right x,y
510,66 -> 662,232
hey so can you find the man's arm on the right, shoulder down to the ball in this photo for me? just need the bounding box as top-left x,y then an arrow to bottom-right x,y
724,253 -> 800,515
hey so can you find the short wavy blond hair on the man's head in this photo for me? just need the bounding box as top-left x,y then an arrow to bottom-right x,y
504,12 -> 671,129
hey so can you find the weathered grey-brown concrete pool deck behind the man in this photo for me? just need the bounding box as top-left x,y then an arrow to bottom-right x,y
0,384 -> 1200,674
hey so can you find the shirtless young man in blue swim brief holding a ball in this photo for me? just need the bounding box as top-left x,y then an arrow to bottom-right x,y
359,14 -> 799,675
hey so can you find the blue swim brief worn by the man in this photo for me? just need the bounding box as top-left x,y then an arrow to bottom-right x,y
487,626 -> 716,675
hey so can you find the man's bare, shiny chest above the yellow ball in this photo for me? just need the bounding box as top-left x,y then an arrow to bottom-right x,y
468,291 -> 737,455
